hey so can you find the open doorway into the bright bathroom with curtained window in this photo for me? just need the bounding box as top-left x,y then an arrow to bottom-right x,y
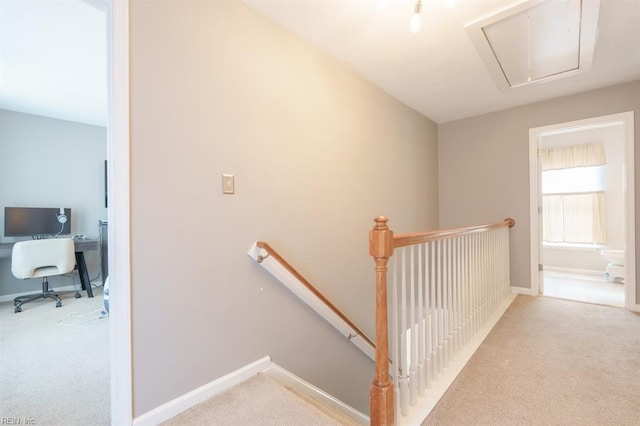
530,113 -> 635,309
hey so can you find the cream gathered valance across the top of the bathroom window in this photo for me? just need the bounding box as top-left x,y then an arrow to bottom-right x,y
538,142 -> 607,171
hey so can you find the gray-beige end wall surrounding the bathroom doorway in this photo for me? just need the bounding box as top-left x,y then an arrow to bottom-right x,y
438,81 -> 640,296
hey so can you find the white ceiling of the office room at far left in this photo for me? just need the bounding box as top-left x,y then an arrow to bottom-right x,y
0,0 -> 107,126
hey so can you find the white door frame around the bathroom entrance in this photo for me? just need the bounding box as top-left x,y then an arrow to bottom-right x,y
529,111 -> 640,312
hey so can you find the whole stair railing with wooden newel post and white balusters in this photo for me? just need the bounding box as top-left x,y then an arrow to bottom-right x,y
369,216 -> 515,425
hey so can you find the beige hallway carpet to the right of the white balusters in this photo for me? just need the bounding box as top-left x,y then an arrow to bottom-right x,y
423,296 -> 640,426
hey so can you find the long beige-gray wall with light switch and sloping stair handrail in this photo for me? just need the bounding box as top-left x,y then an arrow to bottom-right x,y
130,0 -> 440,416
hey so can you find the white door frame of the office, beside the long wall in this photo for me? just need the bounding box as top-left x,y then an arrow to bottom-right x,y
106,0 -> 133,425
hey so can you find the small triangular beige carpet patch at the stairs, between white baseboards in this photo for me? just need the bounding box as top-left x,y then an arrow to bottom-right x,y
163,373 -> 357,426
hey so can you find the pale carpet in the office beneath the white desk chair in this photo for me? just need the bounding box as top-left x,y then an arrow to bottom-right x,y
0,289 -> 110,426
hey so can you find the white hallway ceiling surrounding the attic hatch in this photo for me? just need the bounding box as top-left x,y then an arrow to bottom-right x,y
243,0 -> 640,123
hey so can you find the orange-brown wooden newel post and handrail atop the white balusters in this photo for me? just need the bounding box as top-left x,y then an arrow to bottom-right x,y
369,216 -> 515,426
